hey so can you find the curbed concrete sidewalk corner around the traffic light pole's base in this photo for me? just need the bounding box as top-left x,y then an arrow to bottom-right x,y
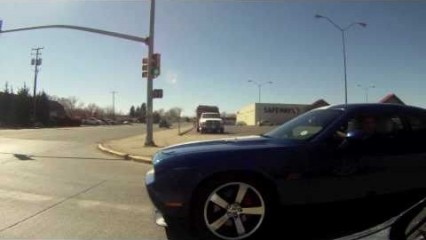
98,125 -> 236,163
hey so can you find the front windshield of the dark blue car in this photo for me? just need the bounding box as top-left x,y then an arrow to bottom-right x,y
263,109 -> 342,141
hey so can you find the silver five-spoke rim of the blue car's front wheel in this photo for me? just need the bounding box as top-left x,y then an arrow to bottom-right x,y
204,182 -> 265,240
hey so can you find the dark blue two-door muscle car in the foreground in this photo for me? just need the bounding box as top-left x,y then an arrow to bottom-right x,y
145,104 -> 426,239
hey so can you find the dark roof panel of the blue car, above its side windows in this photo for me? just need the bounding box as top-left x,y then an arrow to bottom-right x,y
325,103 -> 426,114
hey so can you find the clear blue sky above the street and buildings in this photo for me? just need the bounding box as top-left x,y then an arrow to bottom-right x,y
0,0 -> 426,115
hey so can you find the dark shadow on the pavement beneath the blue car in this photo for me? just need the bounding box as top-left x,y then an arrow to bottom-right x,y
165,191 -> 426,240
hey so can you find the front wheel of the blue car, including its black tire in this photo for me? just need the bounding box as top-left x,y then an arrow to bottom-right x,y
192,176 -> 275,240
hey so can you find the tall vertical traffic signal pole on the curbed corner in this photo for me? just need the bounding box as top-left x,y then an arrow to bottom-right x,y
145,0 -> 155,146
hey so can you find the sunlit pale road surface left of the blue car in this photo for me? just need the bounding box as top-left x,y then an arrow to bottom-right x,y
0,125 -> 166,239
